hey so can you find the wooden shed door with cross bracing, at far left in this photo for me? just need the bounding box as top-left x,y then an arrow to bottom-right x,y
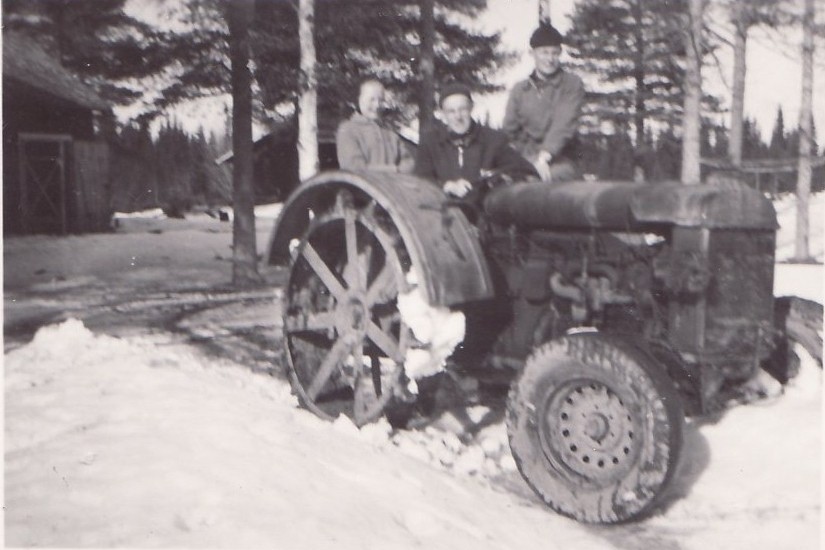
18,133 -> 72,234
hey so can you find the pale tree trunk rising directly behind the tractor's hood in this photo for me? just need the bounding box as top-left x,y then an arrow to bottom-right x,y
682,0 -> 705,185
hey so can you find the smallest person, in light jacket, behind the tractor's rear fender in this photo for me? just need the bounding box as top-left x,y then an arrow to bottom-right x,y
336,79 -> 414,173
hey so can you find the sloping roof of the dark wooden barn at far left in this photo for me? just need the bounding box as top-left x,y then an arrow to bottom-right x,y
3,31 -> 111,111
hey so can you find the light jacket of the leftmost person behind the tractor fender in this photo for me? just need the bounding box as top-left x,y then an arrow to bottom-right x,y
335,113 -> 414,172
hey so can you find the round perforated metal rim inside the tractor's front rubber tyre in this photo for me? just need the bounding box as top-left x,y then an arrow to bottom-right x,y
540,380 -> 638,482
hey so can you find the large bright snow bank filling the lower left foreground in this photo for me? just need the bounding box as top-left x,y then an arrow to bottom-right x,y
5,321 -> 604,550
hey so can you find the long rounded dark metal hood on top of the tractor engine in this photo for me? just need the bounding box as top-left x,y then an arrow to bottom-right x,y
485,181 -> 777,231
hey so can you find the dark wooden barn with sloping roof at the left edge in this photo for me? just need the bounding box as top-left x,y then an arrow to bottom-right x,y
3,31 -> 111,235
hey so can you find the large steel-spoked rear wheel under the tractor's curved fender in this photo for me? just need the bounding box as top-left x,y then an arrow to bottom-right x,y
284,190 -> 409,426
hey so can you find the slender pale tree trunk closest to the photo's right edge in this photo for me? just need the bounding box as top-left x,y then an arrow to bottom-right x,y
794,0 -> 815,260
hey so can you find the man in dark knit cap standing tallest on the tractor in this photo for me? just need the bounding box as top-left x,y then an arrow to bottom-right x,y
503,24 -> 584,183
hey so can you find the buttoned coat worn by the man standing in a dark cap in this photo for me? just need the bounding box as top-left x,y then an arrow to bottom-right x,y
503,70 -> 584,162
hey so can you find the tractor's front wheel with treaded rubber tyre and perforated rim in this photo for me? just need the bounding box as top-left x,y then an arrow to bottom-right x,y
507,333 -> 684,523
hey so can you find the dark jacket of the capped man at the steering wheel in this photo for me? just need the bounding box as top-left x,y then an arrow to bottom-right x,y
415,122 -> 538,184
